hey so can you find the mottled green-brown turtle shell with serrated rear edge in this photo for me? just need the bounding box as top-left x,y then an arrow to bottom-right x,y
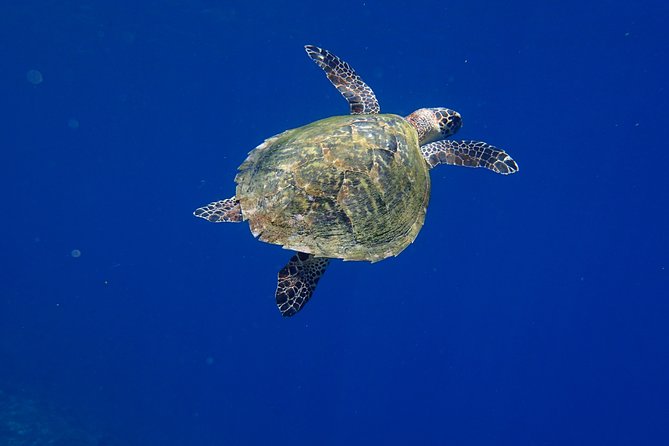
235,115 -> 430,261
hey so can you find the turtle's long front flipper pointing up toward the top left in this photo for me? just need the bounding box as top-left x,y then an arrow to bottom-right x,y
304,45 -> 380,115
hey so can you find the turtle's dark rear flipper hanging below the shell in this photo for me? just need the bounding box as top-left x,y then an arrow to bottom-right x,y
276,252 -> 330,317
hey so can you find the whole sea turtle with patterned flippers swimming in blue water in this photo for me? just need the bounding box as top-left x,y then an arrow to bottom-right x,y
194,45 -> 518,316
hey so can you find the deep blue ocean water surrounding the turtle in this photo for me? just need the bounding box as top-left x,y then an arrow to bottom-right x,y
0,0 -> 669,446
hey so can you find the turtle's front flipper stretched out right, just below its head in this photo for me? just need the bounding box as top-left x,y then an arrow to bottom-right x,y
420,140 -> 518,175
